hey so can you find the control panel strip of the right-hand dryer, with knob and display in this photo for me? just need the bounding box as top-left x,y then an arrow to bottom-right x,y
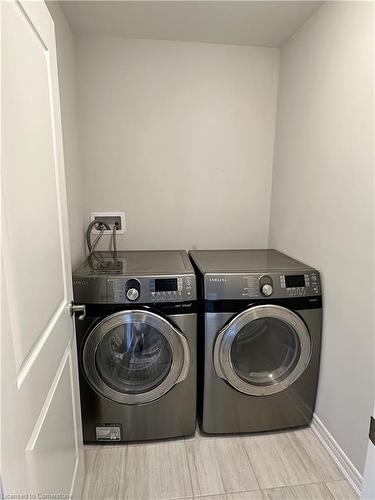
204,268 -> 321,300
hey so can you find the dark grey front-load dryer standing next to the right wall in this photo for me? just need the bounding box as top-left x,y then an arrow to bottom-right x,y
190,250 -> 322,434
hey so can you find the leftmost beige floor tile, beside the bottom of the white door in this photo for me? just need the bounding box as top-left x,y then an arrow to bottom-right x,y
82,445 -> 127,500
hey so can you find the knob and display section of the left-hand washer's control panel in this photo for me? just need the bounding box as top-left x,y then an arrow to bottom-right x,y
106,275 -> 197,304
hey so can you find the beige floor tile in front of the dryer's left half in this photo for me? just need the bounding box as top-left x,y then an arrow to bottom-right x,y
186,437 -> 259,496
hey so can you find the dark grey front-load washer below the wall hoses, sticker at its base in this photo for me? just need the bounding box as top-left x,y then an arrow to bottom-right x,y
73,251 -> 197,443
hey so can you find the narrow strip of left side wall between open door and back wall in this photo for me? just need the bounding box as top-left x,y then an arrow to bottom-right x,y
47,0 -> 86,268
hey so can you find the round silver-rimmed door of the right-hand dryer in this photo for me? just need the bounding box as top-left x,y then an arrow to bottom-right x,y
214,305 -> 311,396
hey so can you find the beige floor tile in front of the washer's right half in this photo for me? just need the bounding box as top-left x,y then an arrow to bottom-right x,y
120,439 -> 193,500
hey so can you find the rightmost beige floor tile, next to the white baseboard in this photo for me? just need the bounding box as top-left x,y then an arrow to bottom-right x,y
243,429 -> 343,488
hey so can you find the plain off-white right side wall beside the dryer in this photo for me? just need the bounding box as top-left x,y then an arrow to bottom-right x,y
270,2 -> 375,472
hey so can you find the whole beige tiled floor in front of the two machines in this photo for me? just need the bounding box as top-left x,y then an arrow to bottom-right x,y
83,429 -> 357,500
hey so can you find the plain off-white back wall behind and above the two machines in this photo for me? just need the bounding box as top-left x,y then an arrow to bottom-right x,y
77,37 -> 279,249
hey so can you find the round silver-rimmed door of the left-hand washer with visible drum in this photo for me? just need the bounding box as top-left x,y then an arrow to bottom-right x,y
82,310 -> 190,404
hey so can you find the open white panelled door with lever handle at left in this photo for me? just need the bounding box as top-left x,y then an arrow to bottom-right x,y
0,1 -> 84,499
